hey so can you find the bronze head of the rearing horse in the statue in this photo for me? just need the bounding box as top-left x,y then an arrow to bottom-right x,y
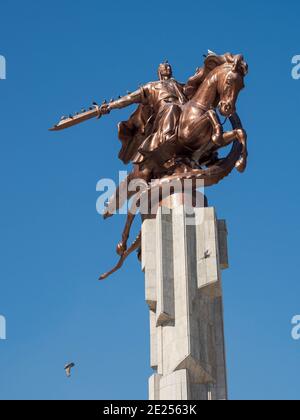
218,55 -> 248,117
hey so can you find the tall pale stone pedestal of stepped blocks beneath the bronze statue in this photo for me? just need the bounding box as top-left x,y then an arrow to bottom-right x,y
142,204 -> 228,400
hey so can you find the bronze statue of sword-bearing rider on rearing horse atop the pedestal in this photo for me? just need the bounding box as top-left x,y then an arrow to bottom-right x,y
52,52 -> 248,279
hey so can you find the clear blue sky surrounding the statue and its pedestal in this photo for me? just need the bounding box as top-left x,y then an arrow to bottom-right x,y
0,0 -> 300,399
